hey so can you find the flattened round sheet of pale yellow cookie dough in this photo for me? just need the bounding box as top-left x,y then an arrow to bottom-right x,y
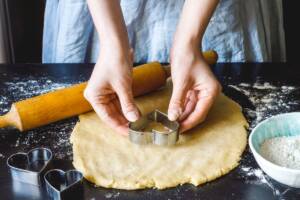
71,87 -> 248,190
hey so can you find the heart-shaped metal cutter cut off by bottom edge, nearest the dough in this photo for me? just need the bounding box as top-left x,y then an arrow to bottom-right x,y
44,169 -> 83,200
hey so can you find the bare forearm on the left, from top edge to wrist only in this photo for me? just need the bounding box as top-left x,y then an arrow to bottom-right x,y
87,0 -> 130,53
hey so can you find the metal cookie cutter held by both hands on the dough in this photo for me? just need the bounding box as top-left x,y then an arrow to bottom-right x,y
129,110 -> 179,146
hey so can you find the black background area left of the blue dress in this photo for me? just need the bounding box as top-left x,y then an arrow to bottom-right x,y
6,0 -> 46,63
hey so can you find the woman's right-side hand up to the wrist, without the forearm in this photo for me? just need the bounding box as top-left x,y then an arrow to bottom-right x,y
168,47 -> 221,132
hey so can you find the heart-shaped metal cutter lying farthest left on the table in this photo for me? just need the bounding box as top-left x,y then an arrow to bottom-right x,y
7,148 -> 52,186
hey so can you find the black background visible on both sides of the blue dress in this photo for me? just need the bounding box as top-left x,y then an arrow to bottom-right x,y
7,0 -> 300,63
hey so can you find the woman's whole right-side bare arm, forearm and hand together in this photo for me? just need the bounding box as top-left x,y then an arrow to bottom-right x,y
168,0 -> 221,132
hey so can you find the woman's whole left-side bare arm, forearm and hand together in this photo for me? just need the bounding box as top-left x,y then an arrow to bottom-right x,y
84,0 -> 139,135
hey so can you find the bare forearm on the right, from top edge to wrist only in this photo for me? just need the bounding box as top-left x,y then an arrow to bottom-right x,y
173,0 -> 219,50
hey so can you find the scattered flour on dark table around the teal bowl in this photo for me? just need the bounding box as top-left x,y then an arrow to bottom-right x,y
229,82 -> 300,199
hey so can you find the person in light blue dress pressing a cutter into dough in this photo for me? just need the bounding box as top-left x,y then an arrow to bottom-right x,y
43,0 -> 285,135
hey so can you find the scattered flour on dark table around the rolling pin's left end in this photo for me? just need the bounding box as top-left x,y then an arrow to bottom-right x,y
0,74 -> 79,160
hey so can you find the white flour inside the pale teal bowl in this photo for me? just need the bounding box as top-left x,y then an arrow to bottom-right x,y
260,136 -> 300,169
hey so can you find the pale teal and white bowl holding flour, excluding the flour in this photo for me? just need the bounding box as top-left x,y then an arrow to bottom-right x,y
249,112 -> 300,188
